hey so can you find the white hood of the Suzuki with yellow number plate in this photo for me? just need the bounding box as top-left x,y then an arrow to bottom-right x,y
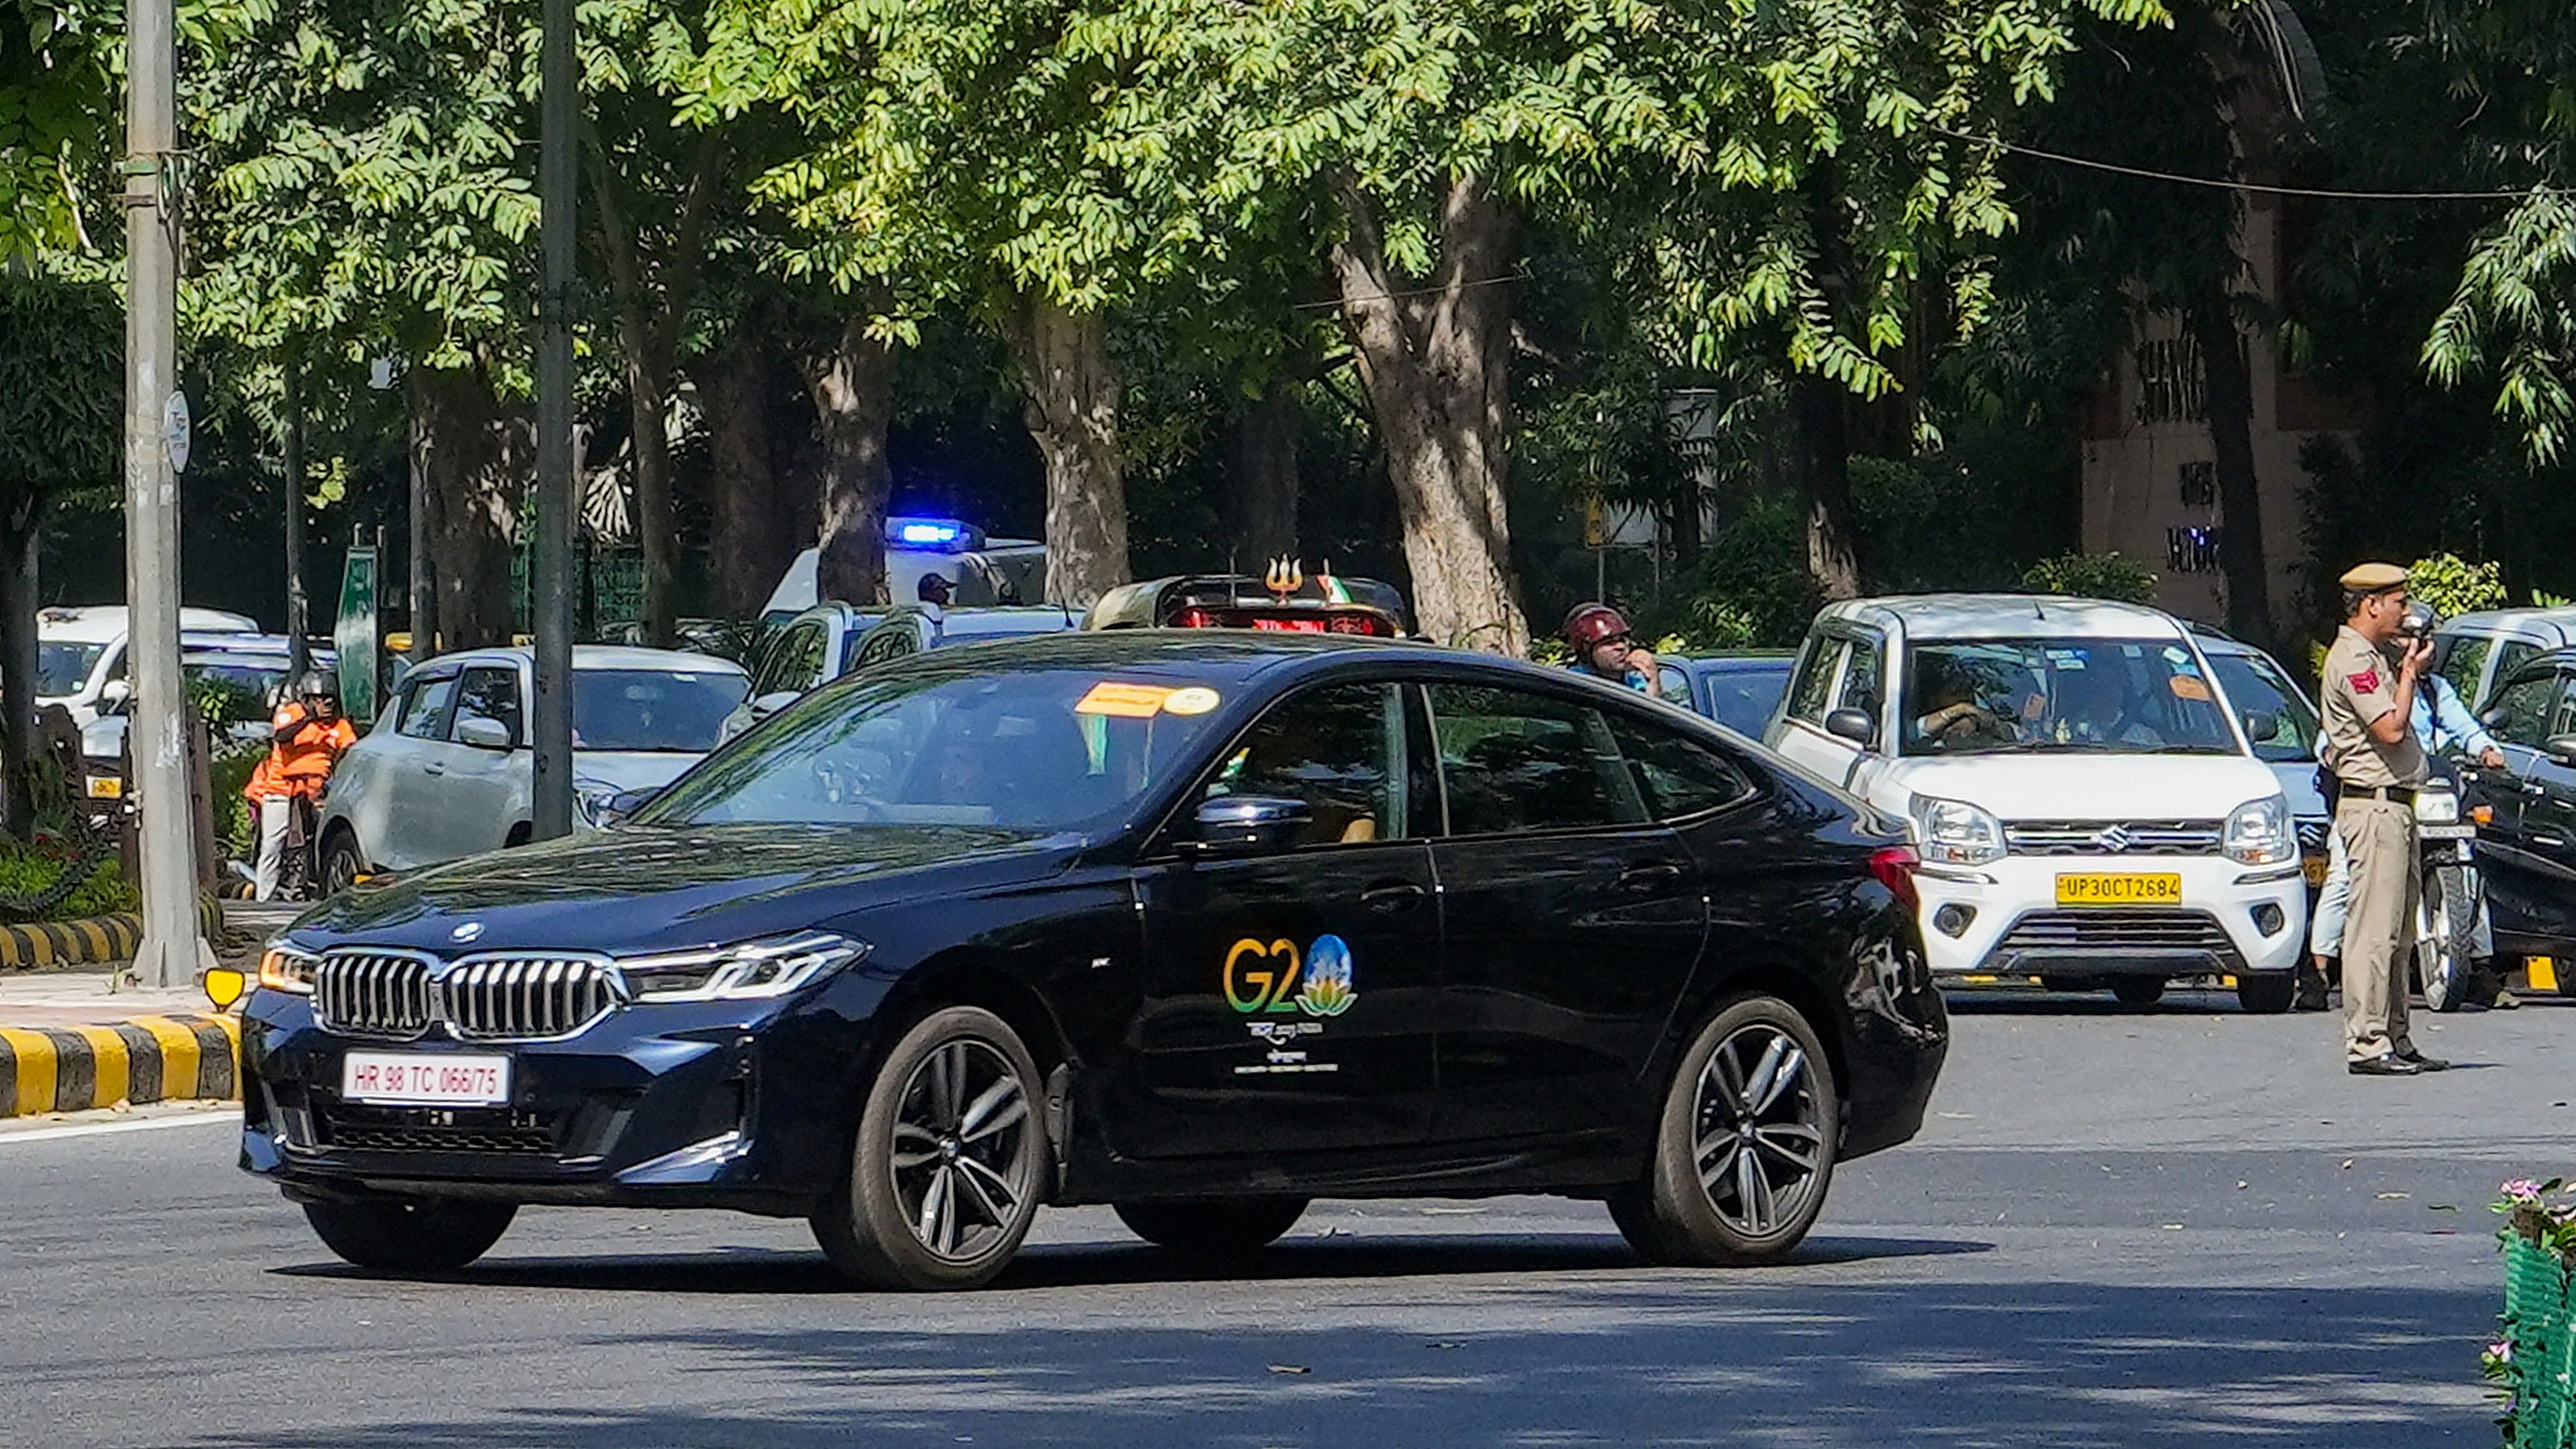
1870,754 -> 2280,821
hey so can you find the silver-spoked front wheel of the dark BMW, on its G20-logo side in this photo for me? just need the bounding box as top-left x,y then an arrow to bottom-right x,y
814,1006 -> 1048,1289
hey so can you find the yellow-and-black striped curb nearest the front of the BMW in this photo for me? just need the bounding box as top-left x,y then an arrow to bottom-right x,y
0,1017 -> 242,1117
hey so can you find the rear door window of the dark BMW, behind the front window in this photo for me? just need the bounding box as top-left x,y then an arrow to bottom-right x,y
1430,685 -> 1646,836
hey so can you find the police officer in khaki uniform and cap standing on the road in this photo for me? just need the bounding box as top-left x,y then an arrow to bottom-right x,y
2324,564 -> 2450,1076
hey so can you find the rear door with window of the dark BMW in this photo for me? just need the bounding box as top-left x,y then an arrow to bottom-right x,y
1427,685 -> 1708,1143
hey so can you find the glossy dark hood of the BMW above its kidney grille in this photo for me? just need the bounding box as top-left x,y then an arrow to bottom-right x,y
291,826 -> 1082,955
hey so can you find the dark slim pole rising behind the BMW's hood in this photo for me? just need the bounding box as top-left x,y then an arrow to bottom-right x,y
528,0 -> 580,839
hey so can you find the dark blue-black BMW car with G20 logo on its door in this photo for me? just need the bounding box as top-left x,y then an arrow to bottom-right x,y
242,631 -> 1947,1289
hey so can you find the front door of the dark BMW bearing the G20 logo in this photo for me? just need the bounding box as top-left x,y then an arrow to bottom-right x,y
1105,680 -> 1440,1158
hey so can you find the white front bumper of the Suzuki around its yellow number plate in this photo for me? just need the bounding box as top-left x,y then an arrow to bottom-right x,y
1917,854 -> 2308,978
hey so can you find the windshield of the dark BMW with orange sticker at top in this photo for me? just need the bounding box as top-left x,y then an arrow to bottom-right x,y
654,662 -> 1219,831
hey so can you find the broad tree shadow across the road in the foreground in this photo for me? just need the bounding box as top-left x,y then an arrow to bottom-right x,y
190,1281 -> 2494,1449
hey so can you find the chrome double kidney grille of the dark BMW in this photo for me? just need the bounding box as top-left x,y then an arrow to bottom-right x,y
314,950 -> 626,1043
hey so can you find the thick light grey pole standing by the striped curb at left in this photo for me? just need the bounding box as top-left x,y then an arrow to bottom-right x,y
124,0 -> 214,988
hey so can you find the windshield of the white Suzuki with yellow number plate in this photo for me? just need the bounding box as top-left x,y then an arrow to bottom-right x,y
1904,638 -> 2236,754
